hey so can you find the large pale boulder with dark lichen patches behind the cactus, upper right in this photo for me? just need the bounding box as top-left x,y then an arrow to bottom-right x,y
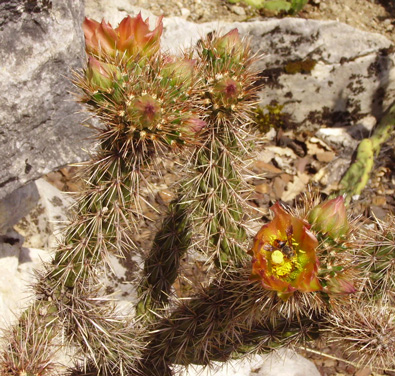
159,18 -> 395,128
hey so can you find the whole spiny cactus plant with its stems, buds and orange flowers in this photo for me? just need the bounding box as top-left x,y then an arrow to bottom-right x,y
0,11 -> 395,376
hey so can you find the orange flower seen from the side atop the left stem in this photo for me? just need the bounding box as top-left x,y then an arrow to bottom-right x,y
82,13 -> 163,58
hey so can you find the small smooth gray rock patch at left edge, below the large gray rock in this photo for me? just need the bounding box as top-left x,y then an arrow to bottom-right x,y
0,183 -> 39,235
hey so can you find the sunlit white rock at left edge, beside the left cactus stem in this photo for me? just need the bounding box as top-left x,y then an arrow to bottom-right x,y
0,179 -> 73,327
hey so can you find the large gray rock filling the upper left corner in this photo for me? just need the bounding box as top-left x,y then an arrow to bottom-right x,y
0,0 -> 89,203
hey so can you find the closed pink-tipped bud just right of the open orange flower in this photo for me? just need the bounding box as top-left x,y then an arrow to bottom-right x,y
308,196 -> 350,239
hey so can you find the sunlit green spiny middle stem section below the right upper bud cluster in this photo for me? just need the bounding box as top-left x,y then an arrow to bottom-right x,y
183,132 -> 248,268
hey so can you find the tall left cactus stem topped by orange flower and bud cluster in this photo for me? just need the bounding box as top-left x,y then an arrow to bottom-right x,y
1,15 -> 202,375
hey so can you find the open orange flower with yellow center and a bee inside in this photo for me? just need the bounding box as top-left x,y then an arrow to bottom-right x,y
252,203 -> 322,300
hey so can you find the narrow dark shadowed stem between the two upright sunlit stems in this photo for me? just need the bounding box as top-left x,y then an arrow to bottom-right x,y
137,200 -> 191,315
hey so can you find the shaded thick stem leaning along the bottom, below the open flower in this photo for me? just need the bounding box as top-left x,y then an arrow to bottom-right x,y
139,264 -> 320,376
